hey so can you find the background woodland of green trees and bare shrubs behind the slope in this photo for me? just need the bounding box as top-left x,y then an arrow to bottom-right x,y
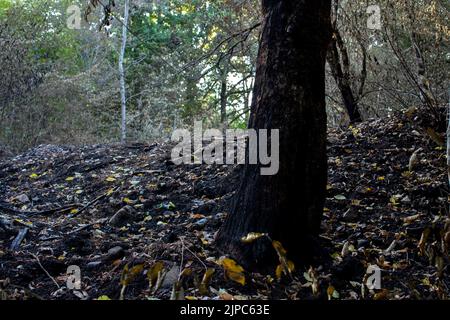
0,0 -> 450,152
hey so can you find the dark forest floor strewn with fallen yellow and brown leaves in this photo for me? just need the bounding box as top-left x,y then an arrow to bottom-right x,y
0,114 -> 450,300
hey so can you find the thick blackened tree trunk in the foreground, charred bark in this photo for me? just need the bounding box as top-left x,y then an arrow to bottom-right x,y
216,0 -> 331,268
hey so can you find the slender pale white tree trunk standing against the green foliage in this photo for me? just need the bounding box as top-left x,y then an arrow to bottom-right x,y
119,0 -> 130,143
